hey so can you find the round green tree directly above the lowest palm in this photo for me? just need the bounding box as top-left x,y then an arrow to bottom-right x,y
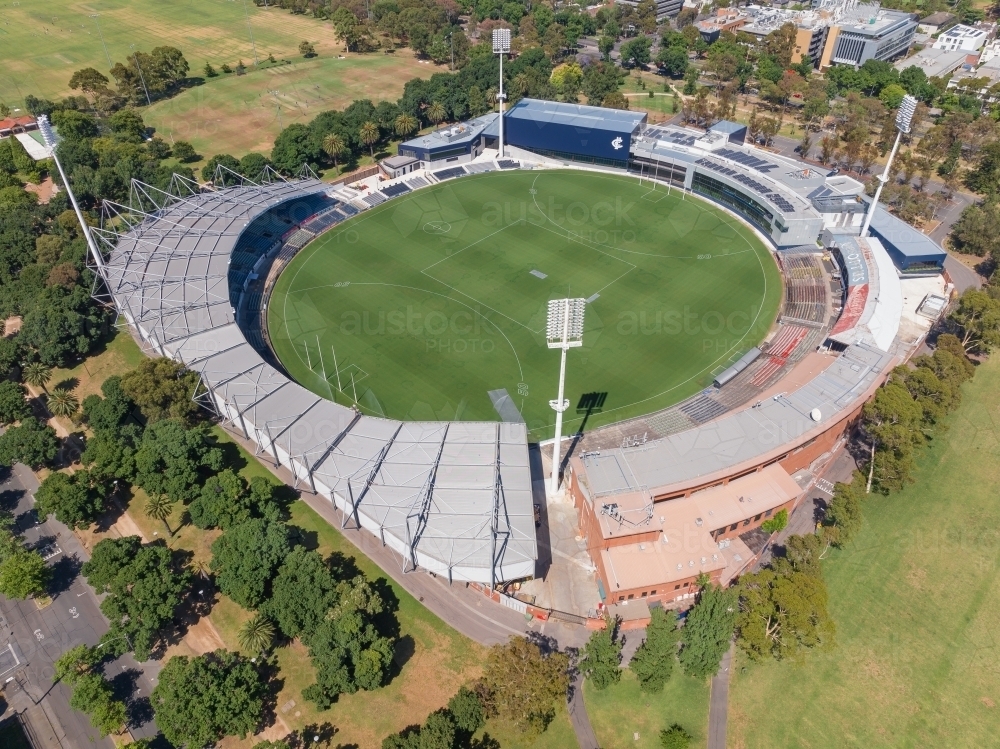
212,518 -> 289,609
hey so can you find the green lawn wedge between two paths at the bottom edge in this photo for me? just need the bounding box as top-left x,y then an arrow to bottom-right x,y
583,665 -> 709,749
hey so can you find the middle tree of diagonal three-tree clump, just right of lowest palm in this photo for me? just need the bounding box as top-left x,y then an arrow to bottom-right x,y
261,546 -> 337,639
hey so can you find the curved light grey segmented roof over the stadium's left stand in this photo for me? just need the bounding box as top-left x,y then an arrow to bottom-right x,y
101,179 -> 537,584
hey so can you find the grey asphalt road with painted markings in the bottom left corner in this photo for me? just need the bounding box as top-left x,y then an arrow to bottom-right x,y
0,466 -> 159,749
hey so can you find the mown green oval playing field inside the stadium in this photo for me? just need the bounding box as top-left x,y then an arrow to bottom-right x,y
268,171 -> 781,438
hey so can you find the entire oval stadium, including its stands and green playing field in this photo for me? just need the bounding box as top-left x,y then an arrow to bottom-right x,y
97,100 -> 948,614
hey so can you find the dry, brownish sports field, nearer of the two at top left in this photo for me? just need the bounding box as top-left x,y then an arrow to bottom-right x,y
142,51 -> 445,167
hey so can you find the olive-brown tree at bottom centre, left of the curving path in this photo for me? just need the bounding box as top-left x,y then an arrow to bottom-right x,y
482,637 -> 569,736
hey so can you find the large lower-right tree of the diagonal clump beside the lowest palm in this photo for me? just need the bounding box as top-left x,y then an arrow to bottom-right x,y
302,575 -> 395,710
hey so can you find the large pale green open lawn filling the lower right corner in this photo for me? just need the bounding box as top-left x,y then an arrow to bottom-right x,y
729,356 -> 1000,749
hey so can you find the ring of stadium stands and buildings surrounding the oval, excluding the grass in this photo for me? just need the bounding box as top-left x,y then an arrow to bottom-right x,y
97,100 -> 944,604
